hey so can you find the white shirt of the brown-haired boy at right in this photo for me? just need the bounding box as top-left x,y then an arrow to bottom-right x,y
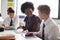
40,18 -> 59,40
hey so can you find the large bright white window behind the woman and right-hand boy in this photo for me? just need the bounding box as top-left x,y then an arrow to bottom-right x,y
16,0 -> 59,18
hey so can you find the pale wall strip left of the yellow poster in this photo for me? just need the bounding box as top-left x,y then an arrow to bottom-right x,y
1,0 -> 7,18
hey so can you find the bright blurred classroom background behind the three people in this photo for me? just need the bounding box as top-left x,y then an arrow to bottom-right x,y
0,0 -> 60,33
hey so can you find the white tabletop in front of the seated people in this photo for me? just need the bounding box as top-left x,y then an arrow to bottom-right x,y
0,30 -> 41,40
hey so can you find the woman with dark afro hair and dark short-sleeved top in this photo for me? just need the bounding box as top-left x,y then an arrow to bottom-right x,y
17,2 -> 41,32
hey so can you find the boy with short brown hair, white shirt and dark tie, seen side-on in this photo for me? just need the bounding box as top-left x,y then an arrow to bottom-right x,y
27,5 -> 59,40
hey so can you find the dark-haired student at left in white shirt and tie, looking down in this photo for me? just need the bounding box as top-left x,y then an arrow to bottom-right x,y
3,8 -> 19,29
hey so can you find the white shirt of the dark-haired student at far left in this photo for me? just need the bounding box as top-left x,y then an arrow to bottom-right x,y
3,15 -> 19,29
